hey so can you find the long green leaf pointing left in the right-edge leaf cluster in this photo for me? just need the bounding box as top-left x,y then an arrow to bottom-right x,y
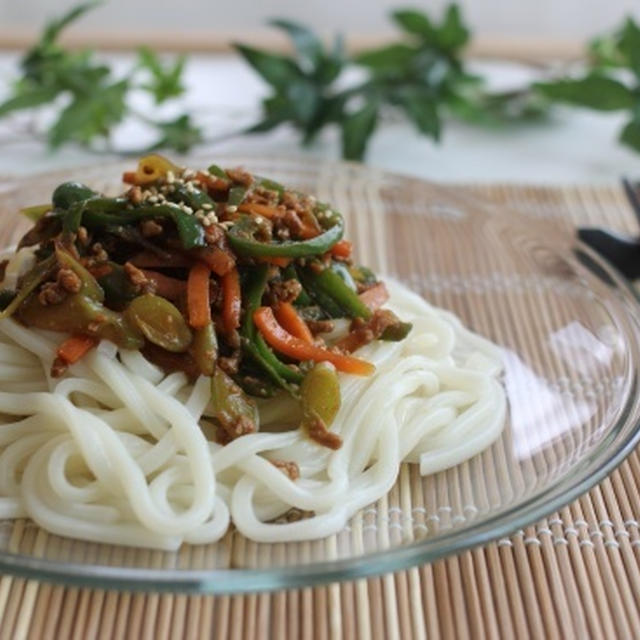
534,73 -> 635,111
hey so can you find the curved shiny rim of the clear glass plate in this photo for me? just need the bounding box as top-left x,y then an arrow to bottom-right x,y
0,235 -> 640,594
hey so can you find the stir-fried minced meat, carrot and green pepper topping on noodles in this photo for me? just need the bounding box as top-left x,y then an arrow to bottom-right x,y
0,155 -> 411,448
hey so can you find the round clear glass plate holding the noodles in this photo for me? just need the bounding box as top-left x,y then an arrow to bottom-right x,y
0,158 -> 640,593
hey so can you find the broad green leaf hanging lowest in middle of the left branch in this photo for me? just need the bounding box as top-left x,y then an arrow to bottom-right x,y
48,80 -> 129,148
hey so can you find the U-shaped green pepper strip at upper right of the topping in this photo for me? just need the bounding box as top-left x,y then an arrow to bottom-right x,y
227,214 -> 344,258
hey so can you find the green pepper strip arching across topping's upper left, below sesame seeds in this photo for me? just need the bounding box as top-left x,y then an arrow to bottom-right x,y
67,198 -> 206,249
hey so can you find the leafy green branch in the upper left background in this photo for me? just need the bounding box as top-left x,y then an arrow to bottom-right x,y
0,1 -> 202,152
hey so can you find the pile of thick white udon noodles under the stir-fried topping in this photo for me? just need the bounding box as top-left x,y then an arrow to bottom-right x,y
0,281 -> 506,550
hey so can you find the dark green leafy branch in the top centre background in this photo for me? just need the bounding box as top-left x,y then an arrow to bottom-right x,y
236,5 -> 544,159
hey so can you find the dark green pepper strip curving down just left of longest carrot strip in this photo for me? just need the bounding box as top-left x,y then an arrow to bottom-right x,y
240,264 -> 304,388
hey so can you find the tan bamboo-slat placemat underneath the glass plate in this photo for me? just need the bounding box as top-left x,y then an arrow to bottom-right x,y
0,181 -> 640,639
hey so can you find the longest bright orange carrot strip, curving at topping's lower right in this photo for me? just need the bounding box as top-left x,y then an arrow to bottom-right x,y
253,307 -> 376,376
